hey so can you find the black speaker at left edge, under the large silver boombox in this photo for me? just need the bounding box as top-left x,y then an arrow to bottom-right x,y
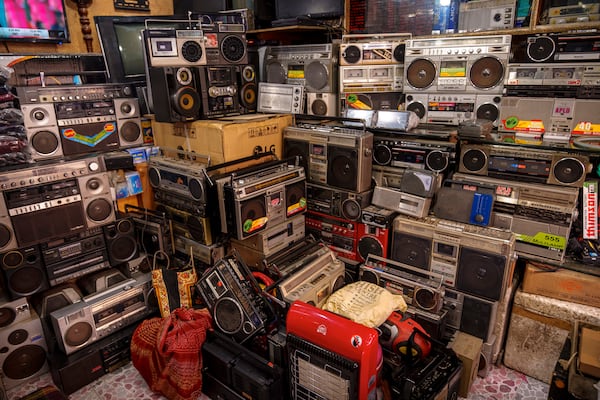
0,246 -> 49,299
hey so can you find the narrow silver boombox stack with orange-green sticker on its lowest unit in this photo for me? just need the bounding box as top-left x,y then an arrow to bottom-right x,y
339,33 -> 411,112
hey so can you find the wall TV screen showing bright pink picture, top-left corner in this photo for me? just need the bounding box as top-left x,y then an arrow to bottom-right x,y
0,0 -> 69,43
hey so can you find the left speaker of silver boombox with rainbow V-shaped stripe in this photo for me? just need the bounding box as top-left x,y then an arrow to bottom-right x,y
21,103 -> 63,160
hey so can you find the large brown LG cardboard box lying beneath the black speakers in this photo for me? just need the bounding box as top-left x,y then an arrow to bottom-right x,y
152,114 -> 292,165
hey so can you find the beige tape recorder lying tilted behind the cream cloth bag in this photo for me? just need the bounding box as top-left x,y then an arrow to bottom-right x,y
273,242 -> 346,308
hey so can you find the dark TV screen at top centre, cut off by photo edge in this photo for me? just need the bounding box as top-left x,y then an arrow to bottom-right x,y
275,0 -> 344,19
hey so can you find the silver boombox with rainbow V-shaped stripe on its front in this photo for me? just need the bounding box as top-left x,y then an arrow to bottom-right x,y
19,84 -> 143,160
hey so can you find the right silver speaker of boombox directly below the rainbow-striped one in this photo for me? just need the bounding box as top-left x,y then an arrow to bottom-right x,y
77,172 -> 115,229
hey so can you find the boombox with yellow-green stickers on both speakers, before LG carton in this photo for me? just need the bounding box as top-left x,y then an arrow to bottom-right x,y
216,160 -> 306,240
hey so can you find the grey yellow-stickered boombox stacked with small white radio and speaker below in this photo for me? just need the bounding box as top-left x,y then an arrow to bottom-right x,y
258,43 -> 338,116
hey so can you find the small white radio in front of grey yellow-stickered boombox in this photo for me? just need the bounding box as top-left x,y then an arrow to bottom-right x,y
257,82 -> 306,114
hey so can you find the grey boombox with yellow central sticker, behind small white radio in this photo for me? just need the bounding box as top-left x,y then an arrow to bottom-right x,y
264,43 -> 338,93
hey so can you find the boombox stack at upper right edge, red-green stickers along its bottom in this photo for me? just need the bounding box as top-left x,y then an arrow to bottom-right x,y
498,34 -> 600,147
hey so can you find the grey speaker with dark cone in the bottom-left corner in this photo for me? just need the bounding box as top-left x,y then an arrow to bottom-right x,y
0,311 -> 48,390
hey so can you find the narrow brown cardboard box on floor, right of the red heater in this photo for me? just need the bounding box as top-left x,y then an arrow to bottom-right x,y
450,331 -> 483,397
